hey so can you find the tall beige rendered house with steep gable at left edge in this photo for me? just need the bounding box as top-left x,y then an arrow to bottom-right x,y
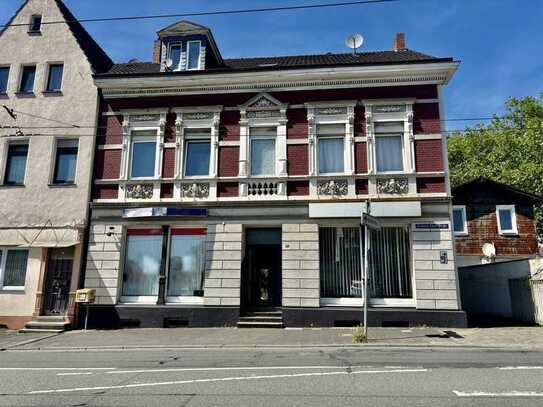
0,0 -> 112,329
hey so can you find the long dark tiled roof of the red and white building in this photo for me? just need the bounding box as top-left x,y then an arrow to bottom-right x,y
99,49 -> 453,76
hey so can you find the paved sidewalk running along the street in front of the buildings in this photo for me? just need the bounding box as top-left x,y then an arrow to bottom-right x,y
0,327 -> 543,351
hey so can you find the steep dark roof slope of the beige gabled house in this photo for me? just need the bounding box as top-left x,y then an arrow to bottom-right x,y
55,0 -> 113,73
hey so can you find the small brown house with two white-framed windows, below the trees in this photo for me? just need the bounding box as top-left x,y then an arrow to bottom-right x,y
452,177 -> 543,267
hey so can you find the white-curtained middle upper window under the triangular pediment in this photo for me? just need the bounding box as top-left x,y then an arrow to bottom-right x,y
249,127 -> 277,175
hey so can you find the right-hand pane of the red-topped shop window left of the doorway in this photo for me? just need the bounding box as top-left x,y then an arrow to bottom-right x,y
167,229 -> 206,297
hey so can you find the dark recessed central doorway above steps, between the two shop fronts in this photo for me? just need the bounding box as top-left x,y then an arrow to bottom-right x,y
241,229 -> 281,308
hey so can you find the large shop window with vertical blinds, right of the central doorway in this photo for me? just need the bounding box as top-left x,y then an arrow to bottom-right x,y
319,227 -> 412,298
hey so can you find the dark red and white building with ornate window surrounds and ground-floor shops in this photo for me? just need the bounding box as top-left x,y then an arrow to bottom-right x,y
85,21 -> 465,326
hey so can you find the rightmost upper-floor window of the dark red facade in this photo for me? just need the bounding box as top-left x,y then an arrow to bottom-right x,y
375,122 -> 404,172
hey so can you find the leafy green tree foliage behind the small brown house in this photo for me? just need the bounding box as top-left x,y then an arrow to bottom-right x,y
449,93 -> 543,236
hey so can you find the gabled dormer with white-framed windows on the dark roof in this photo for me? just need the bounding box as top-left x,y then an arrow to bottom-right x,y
153,21 -> 223,72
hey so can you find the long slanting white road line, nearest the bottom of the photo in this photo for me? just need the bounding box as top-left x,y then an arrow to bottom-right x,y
28,369 -> 428,394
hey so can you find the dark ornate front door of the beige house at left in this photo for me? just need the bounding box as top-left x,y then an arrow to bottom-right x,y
43,248 -> 74,315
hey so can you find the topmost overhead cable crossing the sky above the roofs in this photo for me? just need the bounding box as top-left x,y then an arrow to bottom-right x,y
0,0 -> 400,28
